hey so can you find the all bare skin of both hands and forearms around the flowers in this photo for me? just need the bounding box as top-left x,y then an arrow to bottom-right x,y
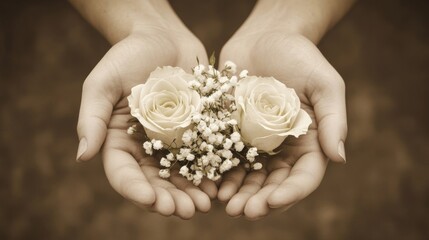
70,0 -> 353,219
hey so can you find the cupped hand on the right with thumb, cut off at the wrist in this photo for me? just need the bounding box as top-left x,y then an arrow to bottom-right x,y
218,32 -> 347,219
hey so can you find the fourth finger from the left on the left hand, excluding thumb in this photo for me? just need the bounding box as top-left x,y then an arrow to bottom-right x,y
170,171 -> 211,212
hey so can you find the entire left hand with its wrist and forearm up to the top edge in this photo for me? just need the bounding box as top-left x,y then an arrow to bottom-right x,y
71,0 -> 217,219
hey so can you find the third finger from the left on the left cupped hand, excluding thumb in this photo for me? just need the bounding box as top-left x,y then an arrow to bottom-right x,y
168,188 -> 195,219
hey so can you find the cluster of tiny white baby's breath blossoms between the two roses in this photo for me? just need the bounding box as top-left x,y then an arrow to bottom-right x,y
127,60 -> 262,186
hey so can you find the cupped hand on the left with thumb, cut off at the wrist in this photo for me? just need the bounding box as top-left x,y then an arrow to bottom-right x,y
77,26 -> 217,219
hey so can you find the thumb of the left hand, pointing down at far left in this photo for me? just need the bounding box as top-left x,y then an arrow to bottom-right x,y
76,58 -> 121,162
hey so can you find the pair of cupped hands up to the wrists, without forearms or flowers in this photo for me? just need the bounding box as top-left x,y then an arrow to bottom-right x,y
77,14 -> 347,219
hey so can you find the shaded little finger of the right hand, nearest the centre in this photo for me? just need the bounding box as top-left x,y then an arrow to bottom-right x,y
217,167 -> 246,202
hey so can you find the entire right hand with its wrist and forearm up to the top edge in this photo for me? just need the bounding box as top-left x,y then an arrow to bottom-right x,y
218,0 -> 353,219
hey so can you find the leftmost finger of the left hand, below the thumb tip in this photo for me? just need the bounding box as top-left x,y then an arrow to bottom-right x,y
103,148 -> 155,207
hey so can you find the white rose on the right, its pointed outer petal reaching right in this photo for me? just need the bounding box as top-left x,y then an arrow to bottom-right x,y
235,76 -> 311,153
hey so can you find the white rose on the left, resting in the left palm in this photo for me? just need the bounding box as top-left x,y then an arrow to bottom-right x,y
128,67 -> 200,147
